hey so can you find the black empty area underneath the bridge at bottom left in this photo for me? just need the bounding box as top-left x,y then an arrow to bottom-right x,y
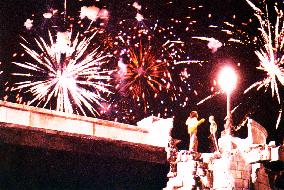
0,142 -> 168,190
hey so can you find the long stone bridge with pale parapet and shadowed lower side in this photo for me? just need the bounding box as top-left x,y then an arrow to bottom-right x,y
0,101 -> 172,164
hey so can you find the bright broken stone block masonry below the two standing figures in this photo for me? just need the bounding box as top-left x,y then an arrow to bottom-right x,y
163,120 -> 284,190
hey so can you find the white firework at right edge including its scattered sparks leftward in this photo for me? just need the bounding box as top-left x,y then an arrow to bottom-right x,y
212,0 -> 284,103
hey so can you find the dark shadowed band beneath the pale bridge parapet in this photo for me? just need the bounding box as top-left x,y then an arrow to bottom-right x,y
0,122 -> 166,163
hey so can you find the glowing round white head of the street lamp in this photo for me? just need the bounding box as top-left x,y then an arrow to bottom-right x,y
218,67 -> 237,93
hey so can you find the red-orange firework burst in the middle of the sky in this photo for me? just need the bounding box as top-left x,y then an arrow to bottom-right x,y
118,38 -> 171,102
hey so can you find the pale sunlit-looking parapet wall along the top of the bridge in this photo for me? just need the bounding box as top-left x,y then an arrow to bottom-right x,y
0,101 -> 172,147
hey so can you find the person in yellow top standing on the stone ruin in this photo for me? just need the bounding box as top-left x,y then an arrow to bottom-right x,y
185,111 -> 205,152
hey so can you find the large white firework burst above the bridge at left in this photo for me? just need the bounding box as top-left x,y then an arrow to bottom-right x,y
11,32 -> 112,115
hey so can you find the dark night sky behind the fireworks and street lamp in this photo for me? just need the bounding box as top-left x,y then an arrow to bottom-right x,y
0,0 -> 284,151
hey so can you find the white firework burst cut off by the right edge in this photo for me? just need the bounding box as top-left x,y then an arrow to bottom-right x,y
245,0 -> 284,103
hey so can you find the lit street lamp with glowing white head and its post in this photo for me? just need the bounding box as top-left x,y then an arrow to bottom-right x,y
218,66 -> 237,135
